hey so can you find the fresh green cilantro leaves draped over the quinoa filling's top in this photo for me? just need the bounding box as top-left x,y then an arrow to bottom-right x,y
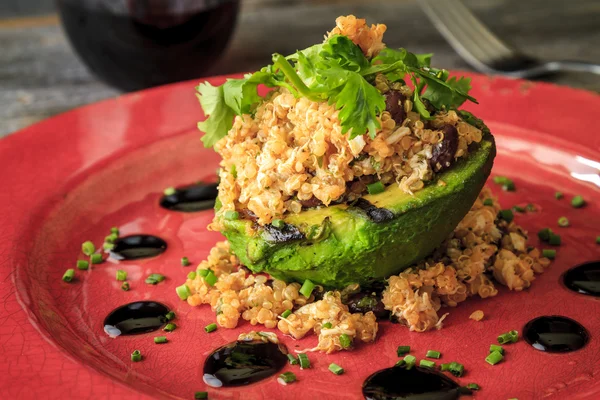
196,35 -> 476,147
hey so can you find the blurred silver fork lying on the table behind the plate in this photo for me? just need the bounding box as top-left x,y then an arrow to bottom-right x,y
419,0 -> 600,78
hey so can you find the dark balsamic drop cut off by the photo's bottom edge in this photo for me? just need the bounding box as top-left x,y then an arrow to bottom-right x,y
362,367 -> 470,400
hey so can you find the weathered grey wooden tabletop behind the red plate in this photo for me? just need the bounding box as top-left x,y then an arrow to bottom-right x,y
0,0 -> 600,137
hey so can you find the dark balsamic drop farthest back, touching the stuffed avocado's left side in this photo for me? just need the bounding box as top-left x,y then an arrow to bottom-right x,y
160,183 -> 219,212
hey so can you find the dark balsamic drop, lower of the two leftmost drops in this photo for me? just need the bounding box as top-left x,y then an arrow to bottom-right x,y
104,301 -> 169,337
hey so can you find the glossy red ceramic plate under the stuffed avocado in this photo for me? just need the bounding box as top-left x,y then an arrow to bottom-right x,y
0,75 -> 600,400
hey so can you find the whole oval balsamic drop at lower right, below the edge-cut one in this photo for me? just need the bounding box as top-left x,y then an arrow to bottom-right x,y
523,315 -> 590,353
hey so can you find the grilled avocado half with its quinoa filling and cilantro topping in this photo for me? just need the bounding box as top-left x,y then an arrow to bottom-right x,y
198,17 -> 495,288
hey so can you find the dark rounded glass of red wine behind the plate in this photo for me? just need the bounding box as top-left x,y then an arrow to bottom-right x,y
56,0 -> 239,91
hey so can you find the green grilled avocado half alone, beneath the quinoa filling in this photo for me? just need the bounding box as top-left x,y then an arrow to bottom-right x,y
222,135 -> 496,288
